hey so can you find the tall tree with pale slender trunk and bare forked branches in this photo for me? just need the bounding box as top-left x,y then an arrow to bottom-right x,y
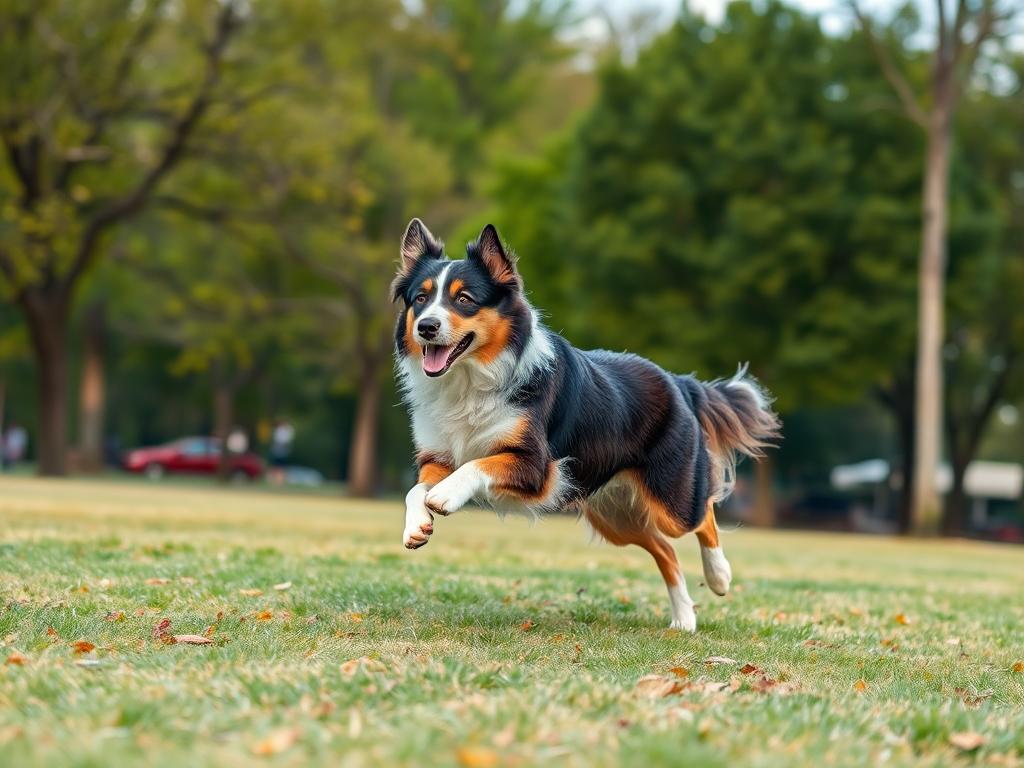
850,0 -> 1014,536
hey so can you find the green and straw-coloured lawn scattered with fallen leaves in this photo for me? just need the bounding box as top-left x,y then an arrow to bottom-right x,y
0,479 -> 1024,768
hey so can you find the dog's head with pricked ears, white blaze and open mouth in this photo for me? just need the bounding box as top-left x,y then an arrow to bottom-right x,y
391,219 -> 529,377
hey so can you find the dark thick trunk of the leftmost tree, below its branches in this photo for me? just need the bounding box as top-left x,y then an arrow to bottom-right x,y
20,291 -> 69,477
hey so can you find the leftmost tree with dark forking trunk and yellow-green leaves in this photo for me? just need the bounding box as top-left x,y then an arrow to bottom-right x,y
0,0 -> 241,474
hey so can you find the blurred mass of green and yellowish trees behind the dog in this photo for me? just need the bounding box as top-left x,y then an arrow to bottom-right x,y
0,0 -> 1024,532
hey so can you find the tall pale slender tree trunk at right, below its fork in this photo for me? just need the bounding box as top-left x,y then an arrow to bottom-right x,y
912,114 -> 951,536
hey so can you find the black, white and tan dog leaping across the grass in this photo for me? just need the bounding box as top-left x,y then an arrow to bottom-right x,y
391,219 -> 780,632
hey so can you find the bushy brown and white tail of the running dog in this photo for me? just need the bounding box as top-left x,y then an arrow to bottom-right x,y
690,364 -> 782,502
